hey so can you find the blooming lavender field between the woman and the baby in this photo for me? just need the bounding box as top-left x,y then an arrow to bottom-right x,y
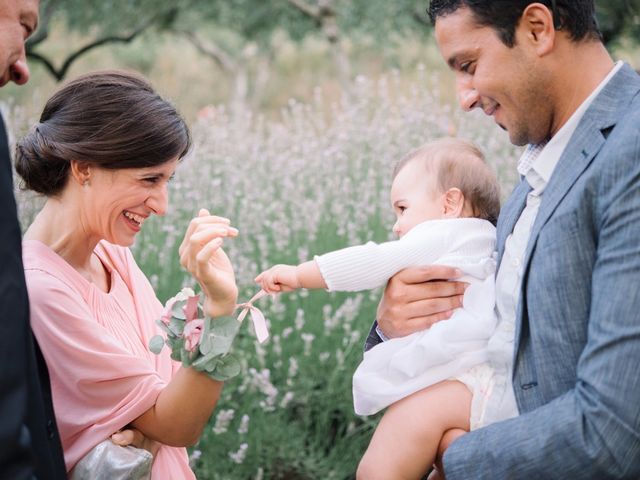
10,69 -> 519,479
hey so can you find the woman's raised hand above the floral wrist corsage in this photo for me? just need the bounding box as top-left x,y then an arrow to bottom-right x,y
178,209 -> 238,317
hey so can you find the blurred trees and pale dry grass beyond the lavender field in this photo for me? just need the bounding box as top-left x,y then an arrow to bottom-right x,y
0,0 -> 640,120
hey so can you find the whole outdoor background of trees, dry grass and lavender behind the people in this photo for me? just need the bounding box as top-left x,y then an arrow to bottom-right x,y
0,0 -> 640,480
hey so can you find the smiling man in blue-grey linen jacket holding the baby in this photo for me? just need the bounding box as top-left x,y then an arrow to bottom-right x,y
368,0 -> 640,479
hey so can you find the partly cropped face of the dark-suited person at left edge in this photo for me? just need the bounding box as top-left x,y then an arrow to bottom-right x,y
0,0 -> 39,87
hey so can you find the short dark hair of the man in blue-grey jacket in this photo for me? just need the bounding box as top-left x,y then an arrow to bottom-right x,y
428,0 -> 602,47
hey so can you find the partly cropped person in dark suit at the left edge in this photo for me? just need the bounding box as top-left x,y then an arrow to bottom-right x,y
0,0 -> 66,480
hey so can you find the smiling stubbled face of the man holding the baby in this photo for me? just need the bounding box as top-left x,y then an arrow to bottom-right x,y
435,7 -> 553,145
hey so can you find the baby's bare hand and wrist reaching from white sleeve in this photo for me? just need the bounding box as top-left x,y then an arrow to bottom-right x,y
255,260 -> 327,293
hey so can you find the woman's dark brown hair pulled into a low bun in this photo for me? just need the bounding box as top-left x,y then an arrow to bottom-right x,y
15,71 -> 191,196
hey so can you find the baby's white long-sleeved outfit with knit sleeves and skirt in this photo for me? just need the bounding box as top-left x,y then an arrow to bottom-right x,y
315,218 -> 496,415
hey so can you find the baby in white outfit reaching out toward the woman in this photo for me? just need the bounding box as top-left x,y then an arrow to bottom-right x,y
256,138 -> 517,480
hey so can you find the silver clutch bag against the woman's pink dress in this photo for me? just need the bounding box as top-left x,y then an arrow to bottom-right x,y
69,439 -> 153,480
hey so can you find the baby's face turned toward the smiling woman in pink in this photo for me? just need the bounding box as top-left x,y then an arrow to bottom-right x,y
391,160 -> 445,237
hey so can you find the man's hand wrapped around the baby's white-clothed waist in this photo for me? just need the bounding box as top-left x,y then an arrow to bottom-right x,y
377,265 -> 468,338
